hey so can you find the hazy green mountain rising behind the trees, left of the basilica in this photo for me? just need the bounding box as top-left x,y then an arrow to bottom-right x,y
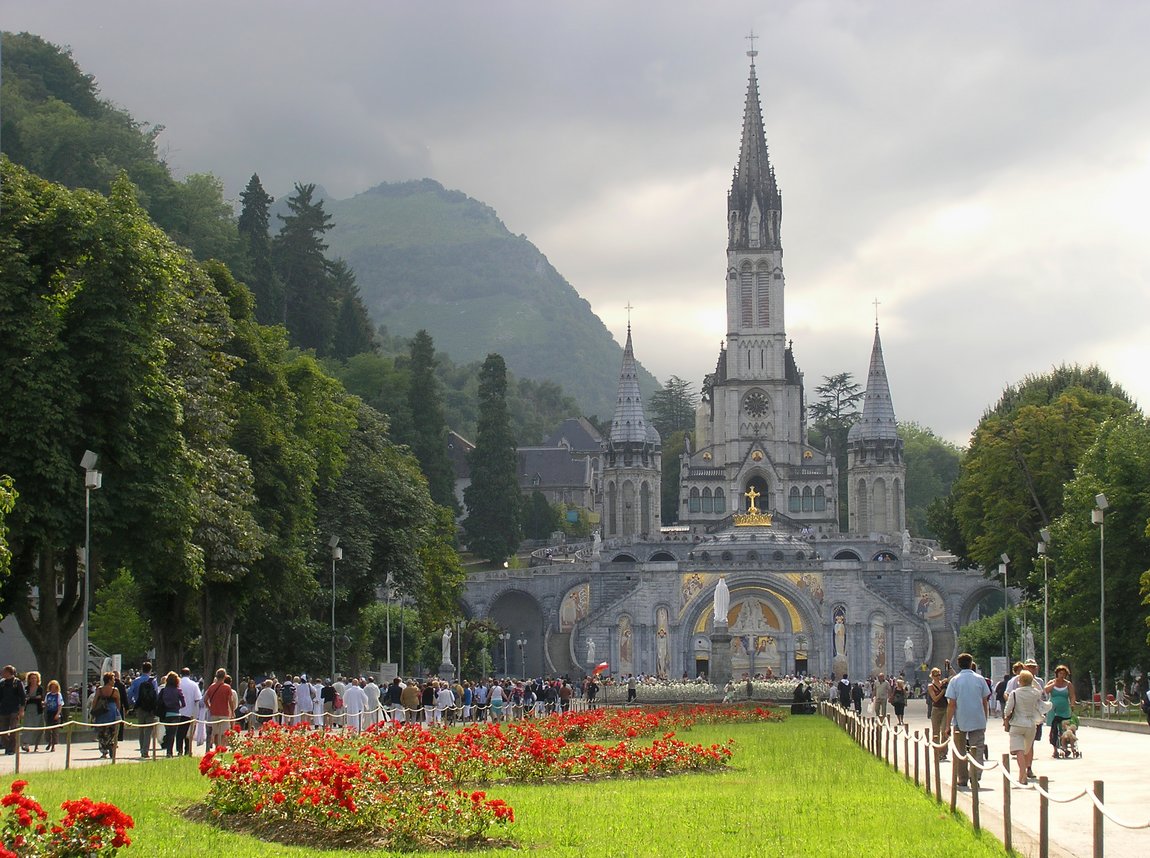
324,178 -> 658,420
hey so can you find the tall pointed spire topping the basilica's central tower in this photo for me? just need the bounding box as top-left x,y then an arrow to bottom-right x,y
727,51 -> 783,250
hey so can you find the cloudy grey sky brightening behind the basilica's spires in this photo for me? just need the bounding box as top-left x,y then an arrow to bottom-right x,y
0,0 -> 1150,443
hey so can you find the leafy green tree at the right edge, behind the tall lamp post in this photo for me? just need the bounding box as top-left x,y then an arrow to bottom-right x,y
1053,414 -> 1150,692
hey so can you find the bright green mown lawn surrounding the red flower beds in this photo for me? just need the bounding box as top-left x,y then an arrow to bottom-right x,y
8,718 -> 1005,858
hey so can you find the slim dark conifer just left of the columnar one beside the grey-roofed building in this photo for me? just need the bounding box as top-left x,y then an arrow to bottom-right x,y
407,330 -> 455,510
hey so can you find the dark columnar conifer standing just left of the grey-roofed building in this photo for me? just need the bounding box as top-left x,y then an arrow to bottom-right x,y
463,354 -> 522,564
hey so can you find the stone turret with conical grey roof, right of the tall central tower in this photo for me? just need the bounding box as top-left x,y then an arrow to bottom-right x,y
846,322 -> 906,538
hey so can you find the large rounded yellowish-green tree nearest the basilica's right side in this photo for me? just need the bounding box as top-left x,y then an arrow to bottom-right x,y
944,369 -> 1133,569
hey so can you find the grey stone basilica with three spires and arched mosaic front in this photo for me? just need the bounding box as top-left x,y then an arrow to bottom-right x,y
465,51 -> 1001,682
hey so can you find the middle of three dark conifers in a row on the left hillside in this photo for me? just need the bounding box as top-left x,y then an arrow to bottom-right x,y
271,183 -> 337,355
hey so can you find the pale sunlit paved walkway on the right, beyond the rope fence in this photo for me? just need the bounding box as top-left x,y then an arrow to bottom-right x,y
883,700 -> 1150,858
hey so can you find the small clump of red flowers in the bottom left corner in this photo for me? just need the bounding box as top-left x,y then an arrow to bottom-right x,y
0,781 -> 135,858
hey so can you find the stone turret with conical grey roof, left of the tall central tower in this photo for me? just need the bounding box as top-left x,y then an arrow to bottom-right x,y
600,324 -> 662,539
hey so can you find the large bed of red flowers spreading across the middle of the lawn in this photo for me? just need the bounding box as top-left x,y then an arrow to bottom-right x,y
200,706 -> 779,846
